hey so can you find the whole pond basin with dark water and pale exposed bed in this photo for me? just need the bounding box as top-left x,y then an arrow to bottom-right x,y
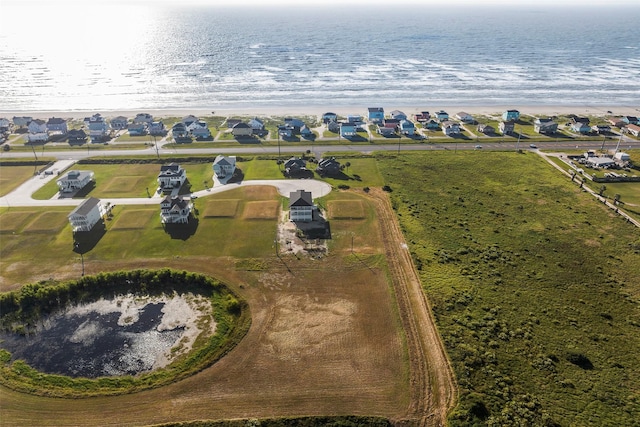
0,294 -> 215,378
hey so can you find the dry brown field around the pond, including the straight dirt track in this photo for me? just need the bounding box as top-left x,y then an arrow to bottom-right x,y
0,192 -> 456,426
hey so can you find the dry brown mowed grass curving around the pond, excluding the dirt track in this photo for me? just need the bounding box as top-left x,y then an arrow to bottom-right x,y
0,256 -> 409,426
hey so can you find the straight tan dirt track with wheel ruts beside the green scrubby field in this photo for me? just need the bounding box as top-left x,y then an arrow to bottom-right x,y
370,189 -> 457,426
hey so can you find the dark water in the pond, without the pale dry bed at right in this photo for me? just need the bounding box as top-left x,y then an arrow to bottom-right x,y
0,302 -> 184,378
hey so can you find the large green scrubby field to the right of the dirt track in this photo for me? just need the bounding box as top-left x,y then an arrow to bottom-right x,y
380,152 -> 640,426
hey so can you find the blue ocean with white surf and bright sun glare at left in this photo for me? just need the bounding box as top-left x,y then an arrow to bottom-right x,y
0,2 -> 640,111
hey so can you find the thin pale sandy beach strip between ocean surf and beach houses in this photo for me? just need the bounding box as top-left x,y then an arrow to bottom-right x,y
0,104 -> 640,119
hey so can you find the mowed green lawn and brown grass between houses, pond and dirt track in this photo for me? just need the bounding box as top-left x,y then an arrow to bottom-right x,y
0,182 -> 410,425
